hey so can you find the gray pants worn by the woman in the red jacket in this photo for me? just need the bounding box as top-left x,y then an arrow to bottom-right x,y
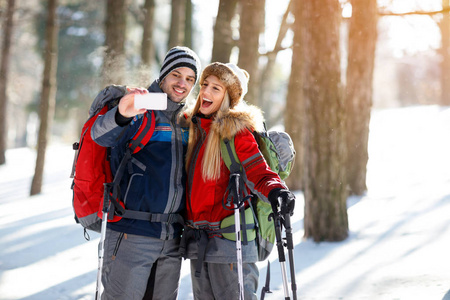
191,259 -> 259,300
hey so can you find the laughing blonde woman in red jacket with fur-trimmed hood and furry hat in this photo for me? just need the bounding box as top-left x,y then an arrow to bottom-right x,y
184,63 -> 295,300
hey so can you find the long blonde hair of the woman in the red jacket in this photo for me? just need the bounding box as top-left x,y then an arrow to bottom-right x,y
186,92 -> 230,180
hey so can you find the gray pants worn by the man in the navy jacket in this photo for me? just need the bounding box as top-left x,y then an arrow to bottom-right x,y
101,229 -> 181,300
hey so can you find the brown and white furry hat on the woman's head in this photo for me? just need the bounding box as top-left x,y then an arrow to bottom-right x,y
200,62 -> 250,108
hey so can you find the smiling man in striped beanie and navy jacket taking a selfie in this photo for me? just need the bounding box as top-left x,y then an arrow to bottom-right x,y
91,47 -> 200,300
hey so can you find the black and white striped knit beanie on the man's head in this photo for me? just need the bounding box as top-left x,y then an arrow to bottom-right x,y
159,46 -> 201,83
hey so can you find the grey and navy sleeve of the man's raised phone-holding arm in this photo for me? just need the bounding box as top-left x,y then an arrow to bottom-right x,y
91,106 -> 133,147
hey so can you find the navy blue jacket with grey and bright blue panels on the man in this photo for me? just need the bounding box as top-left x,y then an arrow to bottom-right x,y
91,81 -> 189,239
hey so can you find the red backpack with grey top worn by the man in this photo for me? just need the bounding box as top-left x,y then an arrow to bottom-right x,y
70,85 -> 155,232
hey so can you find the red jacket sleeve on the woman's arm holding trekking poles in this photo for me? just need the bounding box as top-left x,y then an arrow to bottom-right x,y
234,130 -> 287,202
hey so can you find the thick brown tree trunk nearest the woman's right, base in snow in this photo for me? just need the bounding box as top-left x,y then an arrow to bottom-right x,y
302,0 -> 348,242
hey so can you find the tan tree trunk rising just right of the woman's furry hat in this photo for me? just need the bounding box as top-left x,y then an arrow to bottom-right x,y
238,0 -> 266,105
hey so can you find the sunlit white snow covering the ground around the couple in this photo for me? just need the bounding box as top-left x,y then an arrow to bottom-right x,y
0,106 -> 450,300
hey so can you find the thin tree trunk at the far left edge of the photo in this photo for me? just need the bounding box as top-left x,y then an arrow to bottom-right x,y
0,0 -> 15,165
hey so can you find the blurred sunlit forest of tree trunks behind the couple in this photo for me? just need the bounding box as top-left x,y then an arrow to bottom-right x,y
0,0 -> 450,241
